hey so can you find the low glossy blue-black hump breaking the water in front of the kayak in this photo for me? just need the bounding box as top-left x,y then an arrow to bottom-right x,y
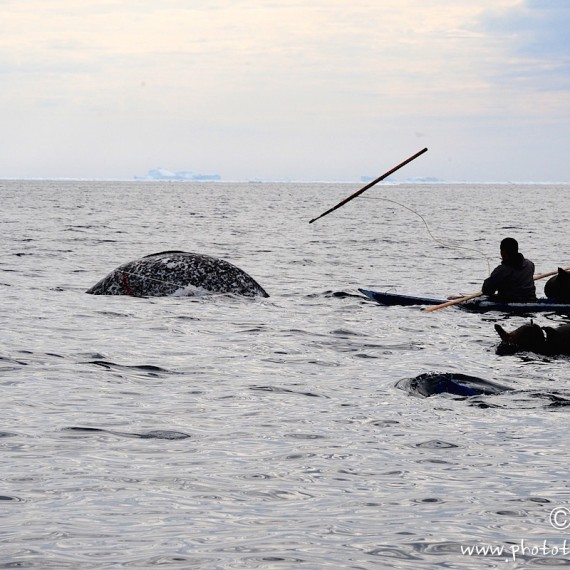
396,372 -> 511,398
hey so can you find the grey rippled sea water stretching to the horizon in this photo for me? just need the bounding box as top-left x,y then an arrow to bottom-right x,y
0,181 -> 570,569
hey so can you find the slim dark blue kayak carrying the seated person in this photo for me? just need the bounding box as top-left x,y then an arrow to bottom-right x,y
359,289 -> 570,314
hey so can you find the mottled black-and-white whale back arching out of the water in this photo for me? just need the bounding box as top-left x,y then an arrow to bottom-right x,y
86,251 -> 269,297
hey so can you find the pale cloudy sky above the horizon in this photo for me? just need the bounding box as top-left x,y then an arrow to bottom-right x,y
0,0 -> 570,182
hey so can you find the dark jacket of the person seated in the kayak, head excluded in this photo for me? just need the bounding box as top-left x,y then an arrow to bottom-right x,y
481,253 -> 536,303
